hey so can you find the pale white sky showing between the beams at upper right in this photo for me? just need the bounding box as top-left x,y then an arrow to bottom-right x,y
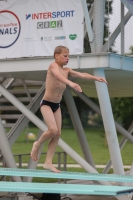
109,0 -> 133,53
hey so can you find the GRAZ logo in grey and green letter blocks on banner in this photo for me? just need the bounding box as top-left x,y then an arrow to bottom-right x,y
37,20 -> 63,29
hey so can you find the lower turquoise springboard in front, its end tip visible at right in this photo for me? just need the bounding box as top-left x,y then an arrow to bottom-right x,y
0,181 -> 133,196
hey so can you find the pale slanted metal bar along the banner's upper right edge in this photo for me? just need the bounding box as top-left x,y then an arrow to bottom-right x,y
81,0 -> 94,42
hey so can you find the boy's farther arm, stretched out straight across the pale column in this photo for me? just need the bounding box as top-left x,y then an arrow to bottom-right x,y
69,69 -> 107,84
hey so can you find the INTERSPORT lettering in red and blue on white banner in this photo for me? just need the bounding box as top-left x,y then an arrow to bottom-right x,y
26,10 -> 75,20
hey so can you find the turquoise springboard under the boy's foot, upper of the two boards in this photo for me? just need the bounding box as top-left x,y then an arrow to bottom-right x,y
0,168 -> 133,182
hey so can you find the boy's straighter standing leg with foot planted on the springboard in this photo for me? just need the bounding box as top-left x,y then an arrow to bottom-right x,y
44,108 -> 62,172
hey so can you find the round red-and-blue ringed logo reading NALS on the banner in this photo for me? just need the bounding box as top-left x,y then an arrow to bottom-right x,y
0,10 -> 21,48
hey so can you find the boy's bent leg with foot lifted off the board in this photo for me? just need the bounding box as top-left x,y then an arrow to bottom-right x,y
31,105 -> 58,161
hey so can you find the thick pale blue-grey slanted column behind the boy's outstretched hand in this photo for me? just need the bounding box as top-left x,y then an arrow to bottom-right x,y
94,69 -> 124,175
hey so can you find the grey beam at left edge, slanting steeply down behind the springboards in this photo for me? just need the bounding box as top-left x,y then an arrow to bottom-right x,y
0,118 -> 21,182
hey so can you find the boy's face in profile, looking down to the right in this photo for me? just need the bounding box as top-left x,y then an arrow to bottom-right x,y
55,49 -> 69,66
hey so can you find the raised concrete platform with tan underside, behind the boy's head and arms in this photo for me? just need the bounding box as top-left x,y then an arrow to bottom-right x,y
0,53 -> 133,97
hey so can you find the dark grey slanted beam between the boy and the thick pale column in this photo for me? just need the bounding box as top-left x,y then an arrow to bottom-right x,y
64,88 -> 95,168
